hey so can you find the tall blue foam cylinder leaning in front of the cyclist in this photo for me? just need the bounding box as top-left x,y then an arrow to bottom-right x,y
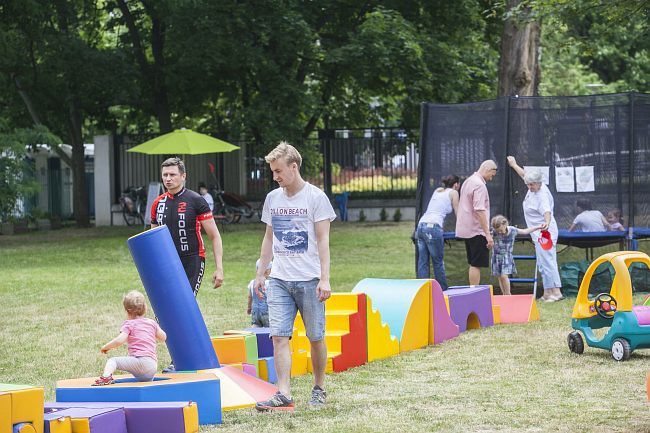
127,226 -> 220,371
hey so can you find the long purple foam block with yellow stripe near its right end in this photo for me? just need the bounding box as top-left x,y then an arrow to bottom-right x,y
45,401 -> 199,433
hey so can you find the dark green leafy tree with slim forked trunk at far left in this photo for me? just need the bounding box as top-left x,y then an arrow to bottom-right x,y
0,0 -> 130,226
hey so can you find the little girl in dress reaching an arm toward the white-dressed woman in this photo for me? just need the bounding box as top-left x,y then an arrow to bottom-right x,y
491,215 -> 541,295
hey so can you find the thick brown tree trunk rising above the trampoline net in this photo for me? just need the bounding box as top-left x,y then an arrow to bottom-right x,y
498,0 -> 541,96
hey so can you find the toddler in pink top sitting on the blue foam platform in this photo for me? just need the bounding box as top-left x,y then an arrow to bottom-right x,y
93,290 -> 167,386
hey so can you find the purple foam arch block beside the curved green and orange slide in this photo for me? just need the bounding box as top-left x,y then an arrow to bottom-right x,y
445,286 -> 494,332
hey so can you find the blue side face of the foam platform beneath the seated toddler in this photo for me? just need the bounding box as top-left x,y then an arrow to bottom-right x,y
56,374 -> 221,424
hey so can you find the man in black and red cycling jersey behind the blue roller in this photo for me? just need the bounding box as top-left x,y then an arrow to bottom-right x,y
151,158 -> 223,296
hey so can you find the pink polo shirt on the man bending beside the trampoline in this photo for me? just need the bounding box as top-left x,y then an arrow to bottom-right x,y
456,172 -> 490,239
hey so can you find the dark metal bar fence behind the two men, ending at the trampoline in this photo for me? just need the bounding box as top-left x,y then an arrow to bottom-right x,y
114,128 -> 418,202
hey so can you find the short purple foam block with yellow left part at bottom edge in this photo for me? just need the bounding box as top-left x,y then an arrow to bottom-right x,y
48,407 -> 129,433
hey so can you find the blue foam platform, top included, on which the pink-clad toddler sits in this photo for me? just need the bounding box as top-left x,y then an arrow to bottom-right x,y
56,373 -> 221,424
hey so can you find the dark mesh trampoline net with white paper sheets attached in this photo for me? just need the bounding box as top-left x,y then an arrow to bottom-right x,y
417,93 -> 650,231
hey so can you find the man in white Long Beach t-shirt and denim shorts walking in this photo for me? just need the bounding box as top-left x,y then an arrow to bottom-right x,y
255,142 -> 336,411
